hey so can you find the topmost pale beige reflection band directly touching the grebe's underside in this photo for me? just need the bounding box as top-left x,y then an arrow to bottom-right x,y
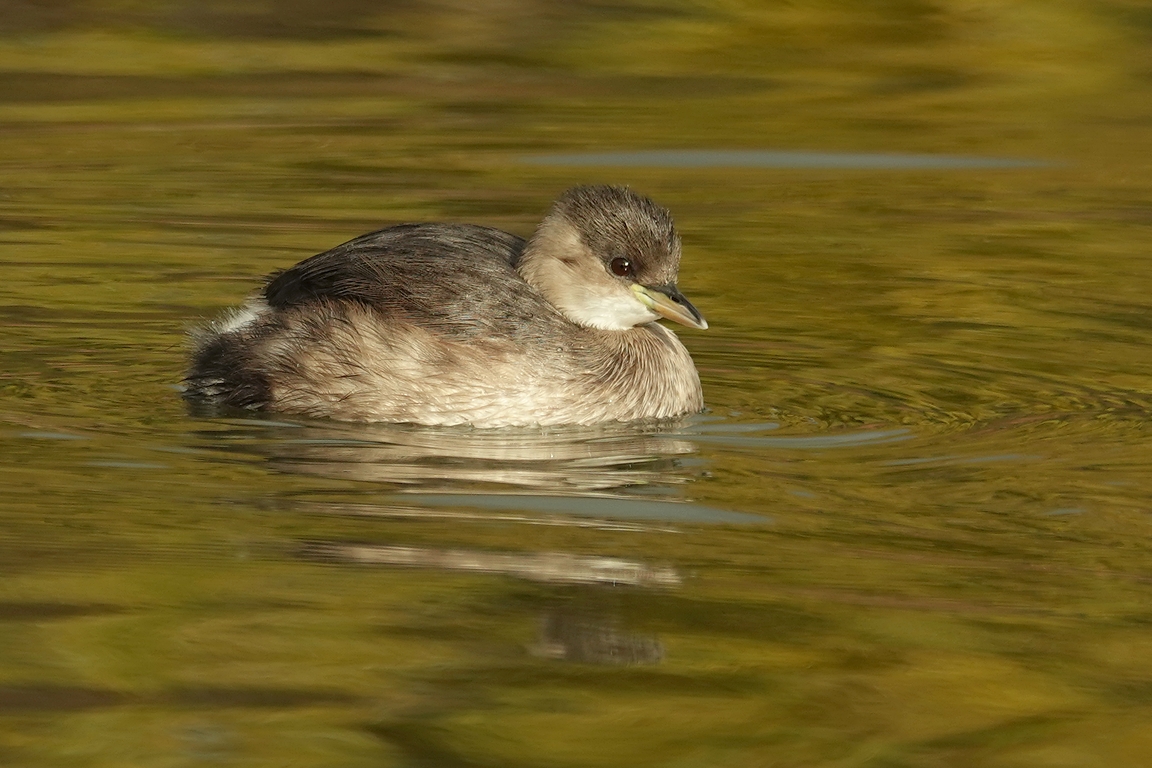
200,419 -> 699,501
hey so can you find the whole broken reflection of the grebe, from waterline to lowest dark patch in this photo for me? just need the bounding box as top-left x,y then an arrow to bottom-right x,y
194,418 -> 718,666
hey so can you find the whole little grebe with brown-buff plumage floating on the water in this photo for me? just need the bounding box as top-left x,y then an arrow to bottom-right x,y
185,187 -> 707,427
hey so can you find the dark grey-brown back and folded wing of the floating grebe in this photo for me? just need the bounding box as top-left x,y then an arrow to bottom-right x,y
264,223 -> 560,339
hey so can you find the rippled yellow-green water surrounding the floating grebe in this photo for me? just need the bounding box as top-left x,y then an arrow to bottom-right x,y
0,0 -> 1152,768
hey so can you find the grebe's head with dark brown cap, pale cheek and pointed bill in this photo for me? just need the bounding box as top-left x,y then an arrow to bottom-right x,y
517,187 -> 708,330
